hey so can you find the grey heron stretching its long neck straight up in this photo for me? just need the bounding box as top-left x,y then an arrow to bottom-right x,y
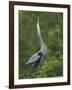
25,16 -> 47,67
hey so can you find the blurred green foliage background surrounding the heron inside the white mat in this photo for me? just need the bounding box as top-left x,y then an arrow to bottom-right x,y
19,10 -> 63,79
